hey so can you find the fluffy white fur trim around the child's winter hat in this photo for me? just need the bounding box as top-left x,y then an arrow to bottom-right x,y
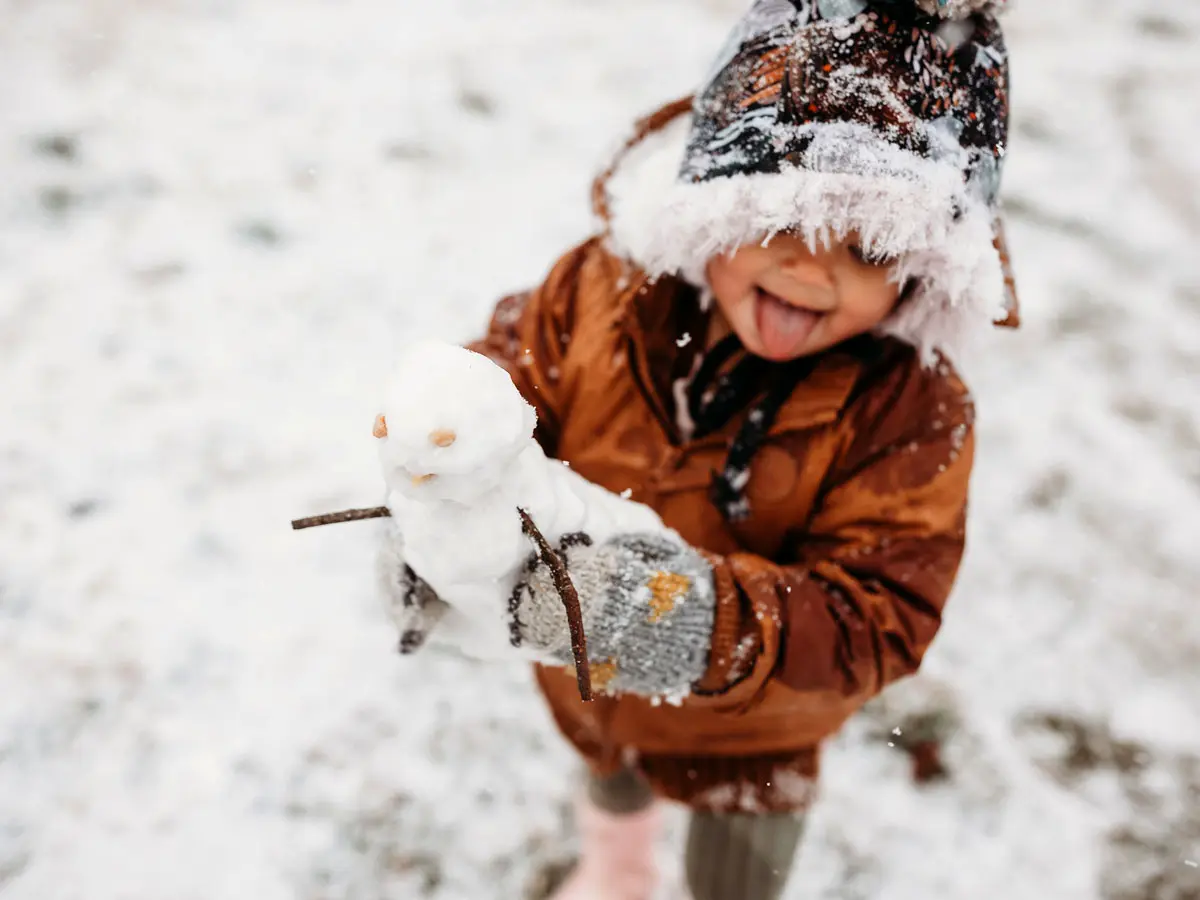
605,108 -> 1007,362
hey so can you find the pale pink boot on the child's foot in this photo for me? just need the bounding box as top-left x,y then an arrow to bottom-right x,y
551,799 -> 662,900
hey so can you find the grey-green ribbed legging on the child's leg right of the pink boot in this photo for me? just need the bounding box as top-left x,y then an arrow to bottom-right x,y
686,812 -> 804,900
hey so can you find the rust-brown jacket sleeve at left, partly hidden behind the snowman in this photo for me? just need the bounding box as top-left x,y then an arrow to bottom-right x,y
467,238 -> 602,456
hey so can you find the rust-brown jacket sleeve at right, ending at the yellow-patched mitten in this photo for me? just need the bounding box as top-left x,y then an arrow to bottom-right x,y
697,366 -> 973,708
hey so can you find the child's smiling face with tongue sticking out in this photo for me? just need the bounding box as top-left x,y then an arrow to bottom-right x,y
707,234 -> 900,361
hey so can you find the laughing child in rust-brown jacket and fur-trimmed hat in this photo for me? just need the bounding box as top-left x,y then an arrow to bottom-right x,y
380,0 -> 1015,900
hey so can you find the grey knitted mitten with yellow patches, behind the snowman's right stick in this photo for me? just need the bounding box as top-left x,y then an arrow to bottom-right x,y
509,534 -> 716,696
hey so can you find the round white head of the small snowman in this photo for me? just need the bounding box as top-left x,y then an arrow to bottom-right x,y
374,341 -> 538,504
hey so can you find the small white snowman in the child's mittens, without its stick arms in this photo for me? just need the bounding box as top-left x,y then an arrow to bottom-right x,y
373,341 -> 673,659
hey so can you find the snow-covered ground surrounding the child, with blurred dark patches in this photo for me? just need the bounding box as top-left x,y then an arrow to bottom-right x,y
0,0 -> 1200,900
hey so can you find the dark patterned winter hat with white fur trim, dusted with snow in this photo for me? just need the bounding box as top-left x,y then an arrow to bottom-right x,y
601,0 -> 1016,360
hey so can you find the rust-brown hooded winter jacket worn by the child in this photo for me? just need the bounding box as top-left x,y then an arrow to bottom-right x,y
463,230 -> 973,811
